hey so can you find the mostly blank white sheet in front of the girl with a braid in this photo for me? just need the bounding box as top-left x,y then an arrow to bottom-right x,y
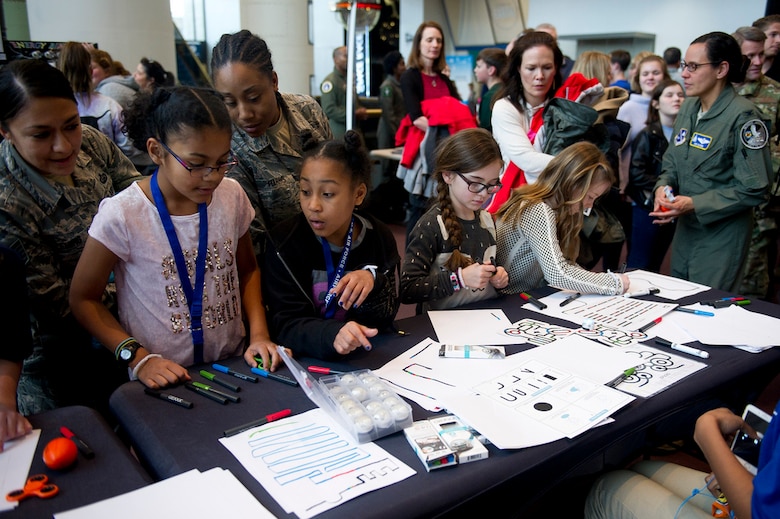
428,308 -> 523,346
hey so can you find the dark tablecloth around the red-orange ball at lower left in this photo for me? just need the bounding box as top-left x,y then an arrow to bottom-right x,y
5,406 -> 152,519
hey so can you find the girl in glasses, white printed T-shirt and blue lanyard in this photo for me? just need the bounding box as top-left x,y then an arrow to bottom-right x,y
70,87 -> 281,388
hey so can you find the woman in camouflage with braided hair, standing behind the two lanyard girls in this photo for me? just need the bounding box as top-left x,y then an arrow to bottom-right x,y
211,30 -> 333,261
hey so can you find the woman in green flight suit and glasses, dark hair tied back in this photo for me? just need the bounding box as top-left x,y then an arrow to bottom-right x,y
650,32 -> 772,292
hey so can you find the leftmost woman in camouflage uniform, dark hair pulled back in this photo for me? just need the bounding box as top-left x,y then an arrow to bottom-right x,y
0,60 -> 140,416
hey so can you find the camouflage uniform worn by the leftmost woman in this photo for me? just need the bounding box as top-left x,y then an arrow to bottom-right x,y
0,125 -> 142,414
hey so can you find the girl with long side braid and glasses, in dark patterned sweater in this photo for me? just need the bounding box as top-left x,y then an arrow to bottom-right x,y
401,128 -> 509,312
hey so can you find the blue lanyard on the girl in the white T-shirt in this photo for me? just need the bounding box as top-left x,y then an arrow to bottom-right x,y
151,170 -> 209,364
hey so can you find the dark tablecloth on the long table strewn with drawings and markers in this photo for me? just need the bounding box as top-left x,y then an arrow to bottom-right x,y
111,291 -> 780,519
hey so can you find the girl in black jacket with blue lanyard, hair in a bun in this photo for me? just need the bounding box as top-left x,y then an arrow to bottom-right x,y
263,130 -> 400,358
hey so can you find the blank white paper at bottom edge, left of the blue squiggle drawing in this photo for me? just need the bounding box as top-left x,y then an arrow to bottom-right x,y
54,468 -> 274,519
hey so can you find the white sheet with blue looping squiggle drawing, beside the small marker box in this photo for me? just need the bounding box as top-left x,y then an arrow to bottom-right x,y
219,408 -> 416,519
